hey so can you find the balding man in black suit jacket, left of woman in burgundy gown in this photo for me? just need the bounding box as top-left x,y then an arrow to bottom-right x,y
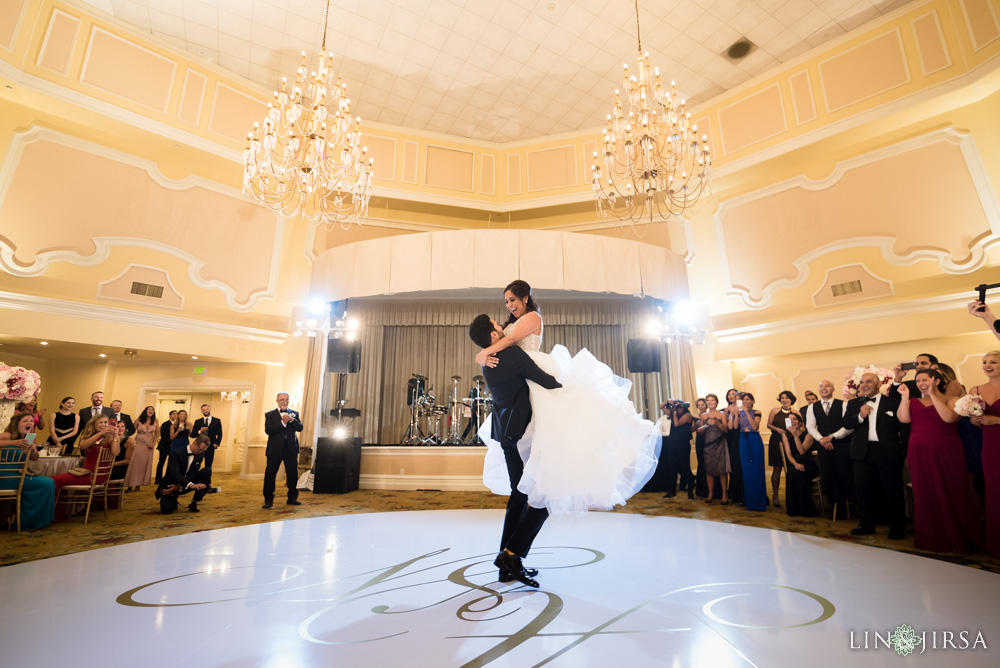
844,373 -> 906,540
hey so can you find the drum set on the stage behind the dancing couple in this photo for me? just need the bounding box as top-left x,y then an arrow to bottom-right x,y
399,373 -> 493,445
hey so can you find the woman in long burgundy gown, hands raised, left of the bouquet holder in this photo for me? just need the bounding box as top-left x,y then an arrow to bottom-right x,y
897,369 -> 982,554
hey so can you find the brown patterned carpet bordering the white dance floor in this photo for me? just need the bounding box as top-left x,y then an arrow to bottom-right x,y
0,472 -> 1000,573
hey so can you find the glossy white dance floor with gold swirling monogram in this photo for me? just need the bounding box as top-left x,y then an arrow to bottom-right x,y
0,510 -> 1000,668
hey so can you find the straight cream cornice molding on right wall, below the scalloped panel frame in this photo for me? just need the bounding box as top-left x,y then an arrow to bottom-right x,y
713,290 -> 975,343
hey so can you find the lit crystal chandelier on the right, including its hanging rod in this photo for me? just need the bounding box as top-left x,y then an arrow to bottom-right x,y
593,0 -> 712,223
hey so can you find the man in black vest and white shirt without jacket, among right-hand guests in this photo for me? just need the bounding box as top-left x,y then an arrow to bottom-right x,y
805,380 -> 854,503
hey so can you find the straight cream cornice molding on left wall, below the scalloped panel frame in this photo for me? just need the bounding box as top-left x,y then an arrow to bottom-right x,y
0,291 -> 288,345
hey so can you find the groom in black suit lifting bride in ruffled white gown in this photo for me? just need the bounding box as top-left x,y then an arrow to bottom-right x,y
469,281 -> 660,587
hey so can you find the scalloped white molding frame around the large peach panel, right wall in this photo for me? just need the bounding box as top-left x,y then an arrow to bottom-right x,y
713,128 -> 1000,309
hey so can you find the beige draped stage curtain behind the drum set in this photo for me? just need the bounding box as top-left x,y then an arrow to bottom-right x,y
323,298 -> 694,445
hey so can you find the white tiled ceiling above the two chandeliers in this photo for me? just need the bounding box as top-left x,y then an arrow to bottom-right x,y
84,0 -> 912,142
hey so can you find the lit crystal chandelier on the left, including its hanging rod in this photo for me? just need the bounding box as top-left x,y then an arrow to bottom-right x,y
243,0 -> 372,228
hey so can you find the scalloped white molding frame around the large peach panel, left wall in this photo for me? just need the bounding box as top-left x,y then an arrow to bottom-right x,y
0,126 -> 284,312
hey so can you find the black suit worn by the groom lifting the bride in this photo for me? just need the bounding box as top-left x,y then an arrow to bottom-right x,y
483,346 -> 562,560
